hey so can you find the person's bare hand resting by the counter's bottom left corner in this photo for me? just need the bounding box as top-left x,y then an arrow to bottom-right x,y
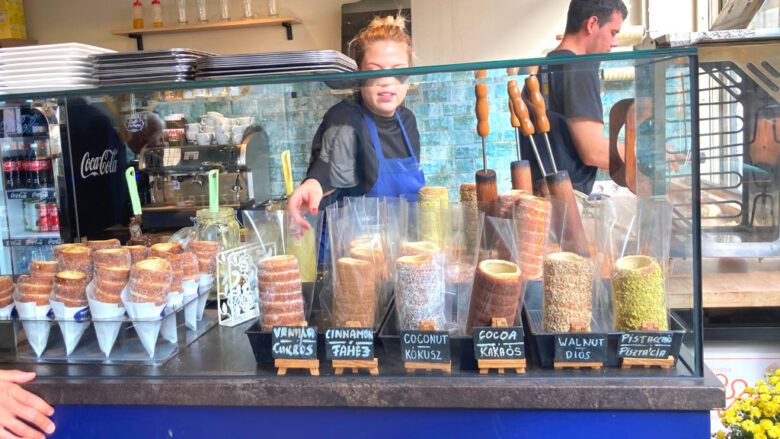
0,370 -> 54,439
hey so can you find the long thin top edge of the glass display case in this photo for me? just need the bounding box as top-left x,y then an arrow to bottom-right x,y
0,47 -> 698,102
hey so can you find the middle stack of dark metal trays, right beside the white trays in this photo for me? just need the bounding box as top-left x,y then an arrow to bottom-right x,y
91,49 -> 214,86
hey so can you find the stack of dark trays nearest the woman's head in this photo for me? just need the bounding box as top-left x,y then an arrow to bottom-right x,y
196,50 -> 357,80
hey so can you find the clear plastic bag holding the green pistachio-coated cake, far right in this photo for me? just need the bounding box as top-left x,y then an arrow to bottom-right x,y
596,196 -> 672,331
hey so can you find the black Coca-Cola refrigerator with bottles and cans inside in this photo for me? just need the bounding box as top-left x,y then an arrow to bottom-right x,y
0,98 -> 129,278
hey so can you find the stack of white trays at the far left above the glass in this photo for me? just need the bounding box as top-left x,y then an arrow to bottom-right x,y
0,43 -> 114,94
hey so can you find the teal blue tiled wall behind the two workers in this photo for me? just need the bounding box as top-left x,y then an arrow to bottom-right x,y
157,59 -> 692,200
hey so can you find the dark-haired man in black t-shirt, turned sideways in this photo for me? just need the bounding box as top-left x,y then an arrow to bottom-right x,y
542,0 -> 628,192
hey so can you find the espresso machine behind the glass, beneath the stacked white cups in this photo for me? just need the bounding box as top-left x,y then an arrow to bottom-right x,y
138,129 -> 269,229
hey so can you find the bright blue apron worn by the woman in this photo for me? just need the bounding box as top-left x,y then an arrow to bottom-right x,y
319,112 -> 425,269
